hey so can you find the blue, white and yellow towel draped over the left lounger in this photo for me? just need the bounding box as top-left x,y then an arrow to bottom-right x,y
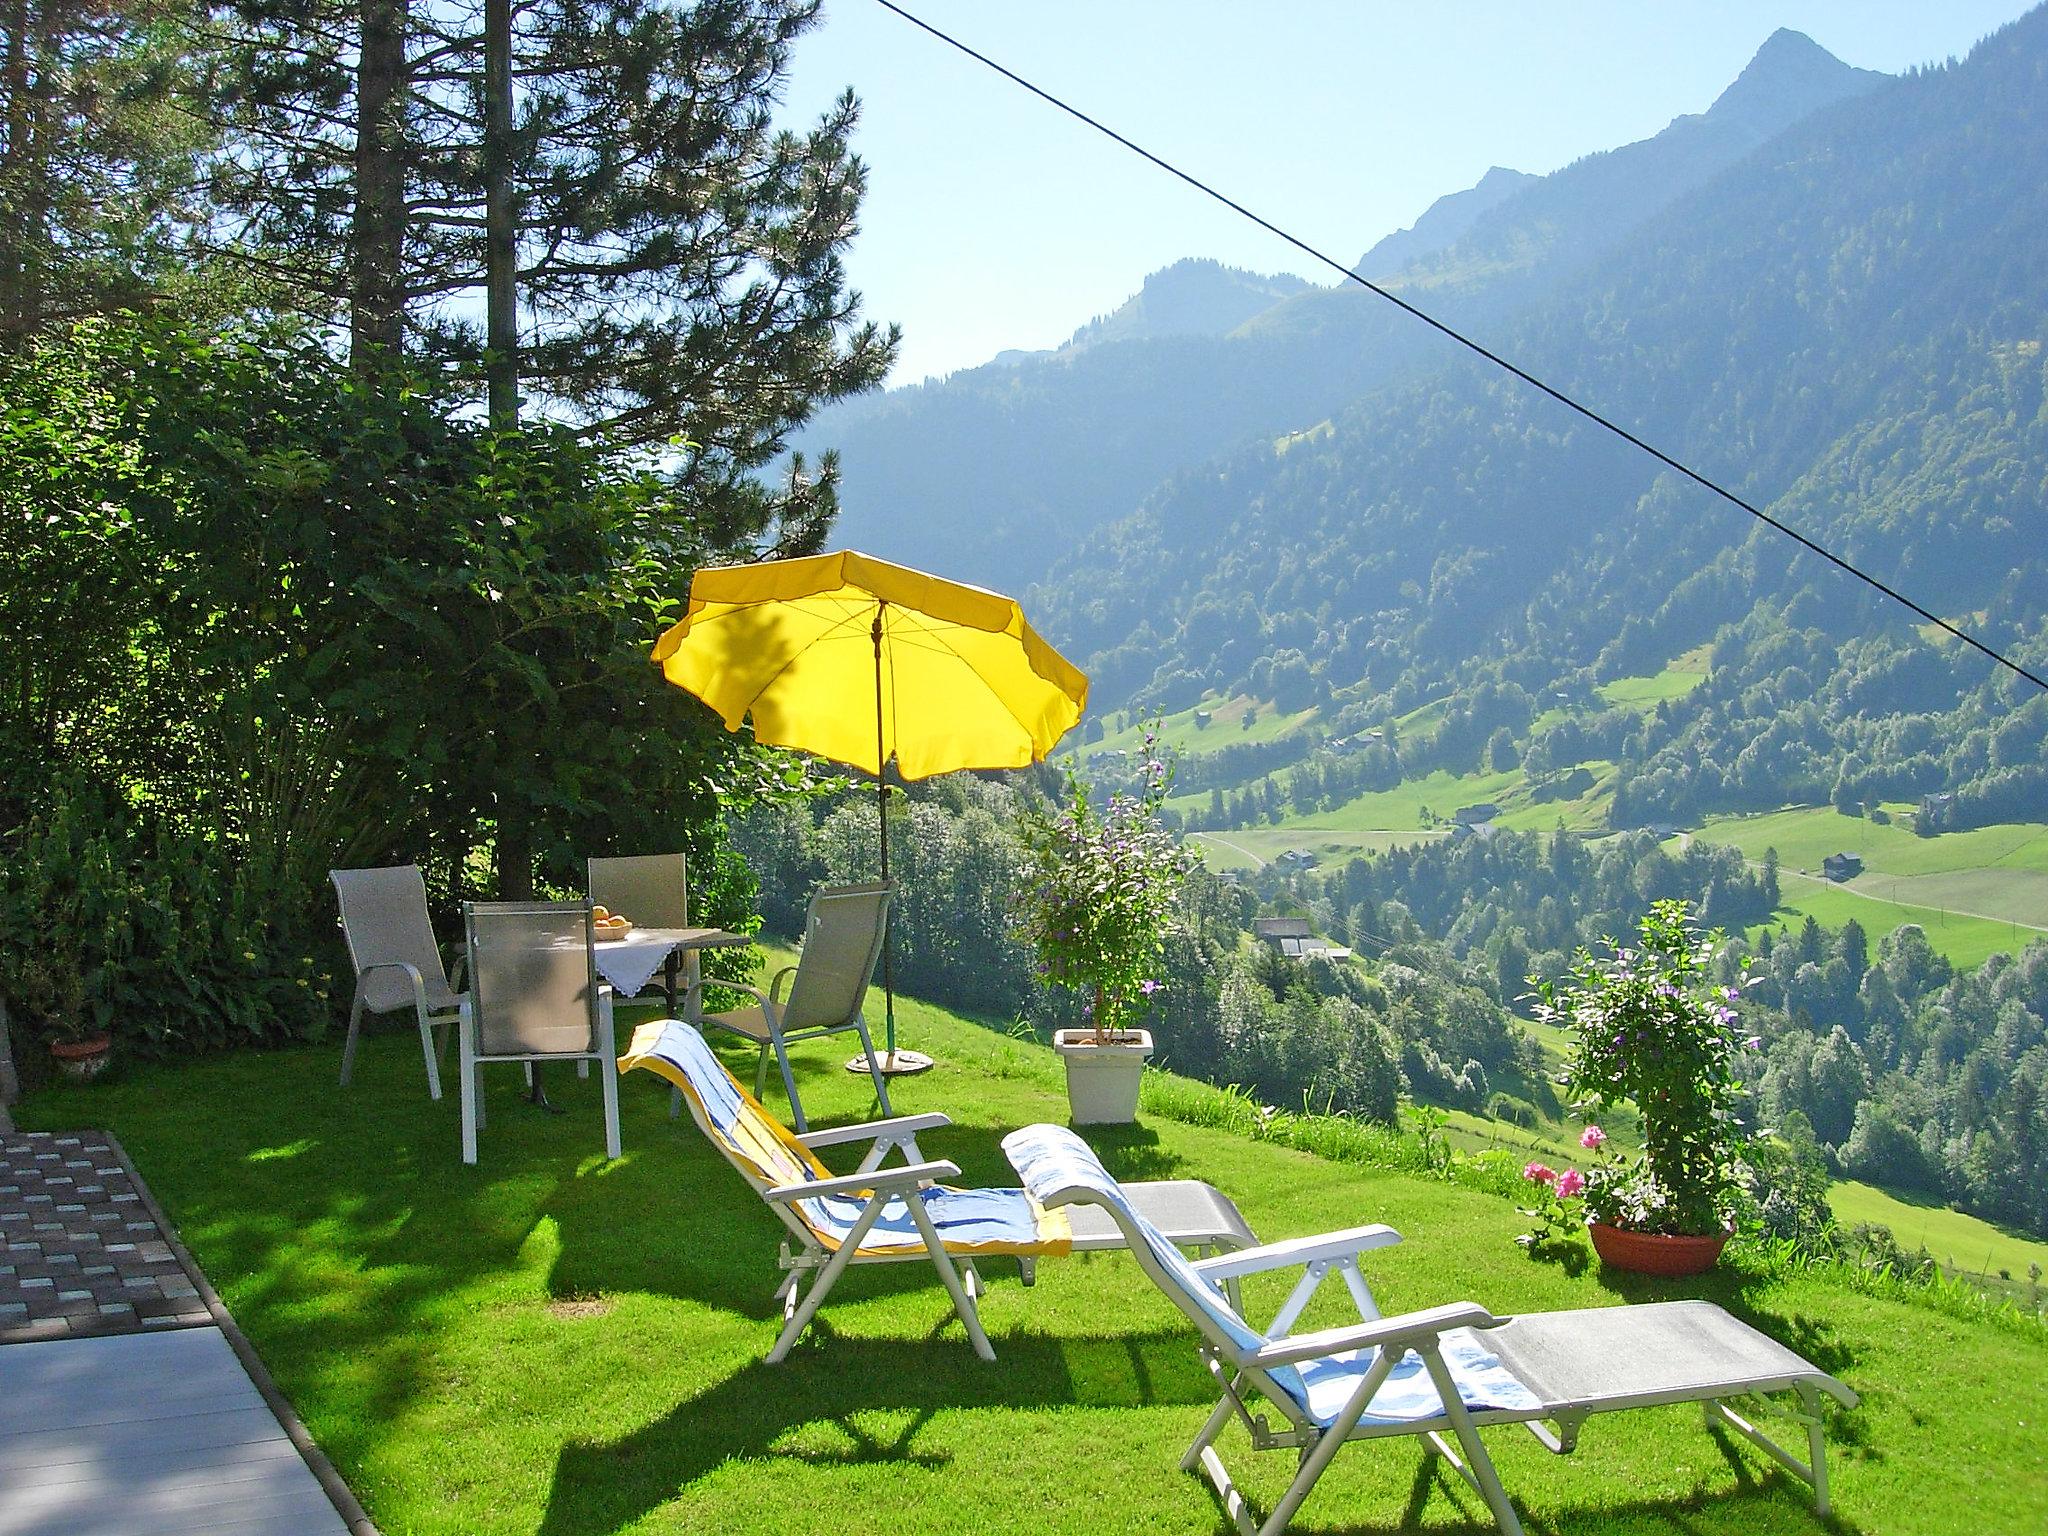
618,1018 -> 1073,1257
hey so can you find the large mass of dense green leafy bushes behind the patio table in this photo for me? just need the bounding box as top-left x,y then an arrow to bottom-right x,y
0,322 -> 782,1047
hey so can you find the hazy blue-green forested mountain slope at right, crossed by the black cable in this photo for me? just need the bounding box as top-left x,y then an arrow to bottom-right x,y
1036,12 -> 2048,831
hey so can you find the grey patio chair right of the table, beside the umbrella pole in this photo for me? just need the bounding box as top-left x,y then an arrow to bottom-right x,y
684,883 -> 895,1133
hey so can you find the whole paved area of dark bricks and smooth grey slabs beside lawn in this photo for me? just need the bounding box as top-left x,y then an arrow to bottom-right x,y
0,1130 -> 377,1536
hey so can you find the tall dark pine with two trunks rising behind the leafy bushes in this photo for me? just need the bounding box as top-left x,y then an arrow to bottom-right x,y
215,0 -> 895,532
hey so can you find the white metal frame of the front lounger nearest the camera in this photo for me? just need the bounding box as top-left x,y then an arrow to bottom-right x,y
1034,1138 -> 1858,1536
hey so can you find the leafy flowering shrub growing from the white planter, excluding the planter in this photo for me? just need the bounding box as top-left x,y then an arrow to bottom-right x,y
1018,727 -> 1194,1040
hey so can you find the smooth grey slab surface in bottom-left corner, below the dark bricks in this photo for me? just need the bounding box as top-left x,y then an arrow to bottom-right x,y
0,1327 -> 348,1536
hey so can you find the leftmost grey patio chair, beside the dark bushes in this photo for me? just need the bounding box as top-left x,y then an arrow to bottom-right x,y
328,864 -> 461,1100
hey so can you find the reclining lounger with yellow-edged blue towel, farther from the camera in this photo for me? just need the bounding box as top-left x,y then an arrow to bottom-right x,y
618,1018 -> 1257,1362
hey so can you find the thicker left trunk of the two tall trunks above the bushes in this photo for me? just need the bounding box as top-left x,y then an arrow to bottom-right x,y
348,0 -> 412,377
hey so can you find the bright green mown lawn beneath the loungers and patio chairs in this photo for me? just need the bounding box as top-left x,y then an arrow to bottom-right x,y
20,1004 -> 2048,1536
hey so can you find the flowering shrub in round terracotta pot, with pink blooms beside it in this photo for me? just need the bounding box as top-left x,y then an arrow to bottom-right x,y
1524,901 -> 1757,1274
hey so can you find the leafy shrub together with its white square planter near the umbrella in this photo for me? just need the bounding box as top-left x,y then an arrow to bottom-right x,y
1020,729 -> 1192,1124
